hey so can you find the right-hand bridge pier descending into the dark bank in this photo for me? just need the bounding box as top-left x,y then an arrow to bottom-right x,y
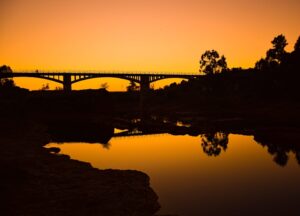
140,75 -> 150,121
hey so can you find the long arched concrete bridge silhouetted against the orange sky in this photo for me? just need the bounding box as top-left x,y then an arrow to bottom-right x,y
0,71 -> 201,92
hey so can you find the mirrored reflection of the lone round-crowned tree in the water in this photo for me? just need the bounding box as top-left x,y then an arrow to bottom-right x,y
201,132 -> 228,156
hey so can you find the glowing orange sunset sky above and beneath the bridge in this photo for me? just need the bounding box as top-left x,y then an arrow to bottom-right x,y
0,0 -> 300,90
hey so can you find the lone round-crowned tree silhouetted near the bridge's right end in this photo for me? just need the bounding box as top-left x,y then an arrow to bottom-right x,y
199,50 -> 227,75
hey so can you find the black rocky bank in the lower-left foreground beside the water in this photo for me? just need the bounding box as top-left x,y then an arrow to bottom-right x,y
0,120 -> 159,216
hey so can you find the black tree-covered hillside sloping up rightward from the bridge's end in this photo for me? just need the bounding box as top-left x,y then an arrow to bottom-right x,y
144,35 -> 300,123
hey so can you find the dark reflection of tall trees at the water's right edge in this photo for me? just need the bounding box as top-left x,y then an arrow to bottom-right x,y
254,133 -> 300,166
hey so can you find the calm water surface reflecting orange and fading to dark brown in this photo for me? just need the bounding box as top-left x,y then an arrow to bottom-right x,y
48,134 -> 300,216
